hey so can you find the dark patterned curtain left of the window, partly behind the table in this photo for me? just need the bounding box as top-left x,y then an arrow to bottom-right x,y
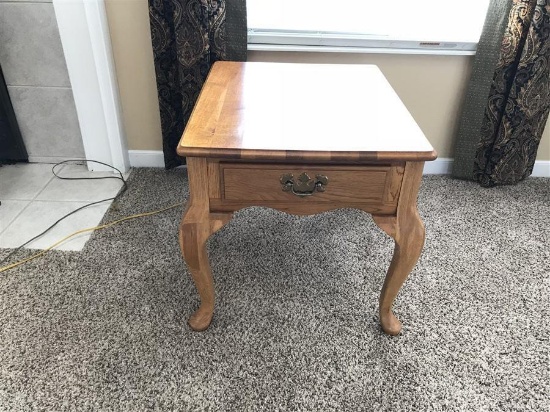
149,0 -> 247,169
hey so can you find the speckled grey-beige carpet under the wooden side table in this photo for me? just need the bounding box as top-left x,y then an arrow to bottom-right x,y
0,169 -> 550,411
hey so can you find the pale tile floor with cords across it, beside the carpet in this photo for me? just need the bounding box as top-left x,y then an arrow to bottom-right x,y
0,163 -> 127,250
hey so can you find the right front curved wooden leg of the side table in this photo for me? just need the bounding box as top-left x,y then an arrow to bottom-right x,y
373,162 -> 425,335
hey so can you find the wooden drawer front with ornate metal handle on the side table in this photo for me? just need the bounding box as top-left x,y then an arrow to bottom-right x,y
220,163 -> 403,206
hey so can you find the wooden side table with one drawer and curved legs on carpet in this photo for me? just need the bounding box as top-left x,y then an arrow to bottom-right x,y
177,62 -> 437,335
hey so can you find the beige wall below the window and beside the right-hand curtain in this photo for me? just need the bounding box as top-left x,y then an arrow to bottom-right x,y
248,52 -> 550,160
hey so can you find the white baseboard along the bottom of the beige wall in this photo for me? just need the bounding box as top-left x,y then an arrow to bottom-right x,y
128,150 -> 550,177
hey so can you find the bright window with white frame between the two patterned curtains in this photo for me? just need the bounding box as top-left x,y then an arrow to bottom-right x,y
247,0 -> 489,54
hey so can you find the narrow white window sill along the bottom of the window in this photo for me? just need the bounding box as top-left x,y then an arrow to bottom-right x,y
248,43 -> 476,56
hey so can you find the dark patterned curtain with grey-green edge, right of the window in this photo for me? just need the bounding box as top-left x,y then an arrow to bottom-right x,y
453,0 -> 550,187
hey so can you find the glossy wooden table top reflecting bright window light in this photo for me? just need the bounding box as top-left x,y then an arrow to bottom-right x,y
177,62 -> 437,162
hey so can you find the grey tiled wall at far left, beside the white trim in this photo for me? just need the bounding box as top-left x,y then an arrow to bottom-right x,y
0,0 -> 84,162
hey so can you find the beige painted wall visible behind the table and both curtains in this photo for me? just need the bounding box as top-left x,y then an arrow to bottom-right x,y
106,0 -> 550,160
